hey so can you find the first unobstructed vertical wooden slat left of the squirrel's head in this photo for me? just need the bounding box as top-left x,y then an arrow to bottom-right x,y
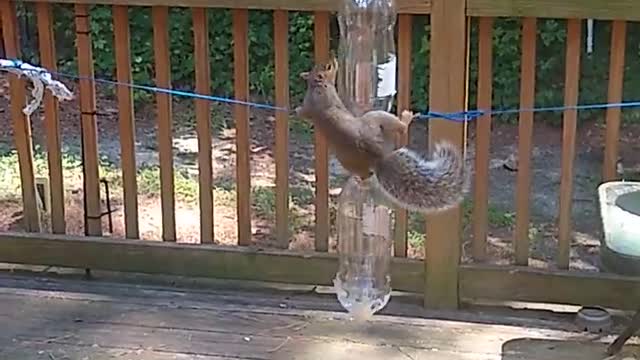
273,10 -> 289,248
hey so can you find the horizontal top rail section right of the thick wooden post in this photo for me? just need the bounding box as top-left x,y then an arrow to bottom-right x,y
467,0 -> 640,20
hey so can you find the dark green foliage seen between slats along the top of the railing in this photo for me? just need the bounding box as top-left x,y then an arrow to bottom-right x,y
13,4 -> 640,124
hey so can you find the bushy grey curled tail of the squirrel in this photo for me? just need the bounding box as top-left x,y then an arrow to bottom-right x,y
374,142 -> 469,213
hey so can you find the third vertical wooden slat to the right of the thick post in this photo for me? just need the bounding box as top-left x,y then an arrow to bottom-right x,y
558,19 -> 582,269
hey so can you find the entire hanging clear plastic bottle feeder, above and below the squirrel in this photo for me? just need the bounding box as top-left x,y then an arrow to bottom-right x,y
334,0 -> 396,321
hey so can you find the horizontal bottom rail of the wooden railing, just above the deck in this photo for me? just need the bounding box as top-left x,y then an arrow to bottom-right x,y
0,233 -> 640,310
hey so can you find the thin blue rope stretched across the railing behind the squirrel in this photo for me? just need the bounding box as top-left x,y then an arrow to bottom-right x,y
11,59 -> 640,122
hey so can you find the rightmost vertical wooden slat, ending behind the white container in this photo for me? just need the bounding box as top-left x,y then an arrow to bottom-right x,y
602,20 -> 627,181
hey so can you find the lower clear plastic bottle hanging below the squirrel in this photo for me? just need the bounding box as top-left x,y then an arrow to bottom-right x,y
333,176 -> 393,321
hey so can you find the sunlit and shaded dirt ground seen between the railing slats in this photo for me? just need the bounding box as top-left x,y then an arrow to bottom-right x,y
0,79 -> 640,271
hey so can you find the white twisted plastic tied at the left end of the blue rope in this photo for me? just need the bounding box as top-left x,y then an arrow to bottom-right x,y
0,59 -> 74,116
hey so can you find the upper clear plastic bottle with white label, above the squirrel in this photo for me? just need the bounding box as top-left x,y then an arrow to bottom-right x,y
338,0 -> 397,115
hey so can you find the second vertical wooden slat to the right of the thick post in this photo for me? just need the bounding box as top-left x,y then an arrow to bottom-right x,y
514,18 -> 537,266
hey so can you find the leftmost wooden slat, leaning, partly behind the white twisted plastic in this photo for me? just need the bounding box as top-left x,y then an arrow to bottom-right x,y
0,0 -> 41,232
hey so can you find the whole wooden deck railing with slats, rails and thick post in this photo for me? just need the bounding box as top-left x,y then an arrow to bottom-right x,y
0,0 -> 640,308
